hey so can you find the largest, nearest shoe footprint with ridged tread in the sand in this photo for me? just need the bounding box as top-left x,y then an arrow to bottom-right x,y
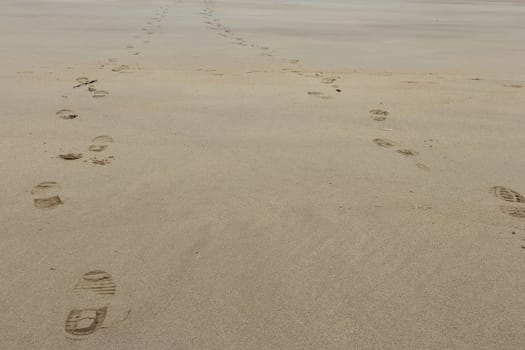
64,270 -> 117,340
